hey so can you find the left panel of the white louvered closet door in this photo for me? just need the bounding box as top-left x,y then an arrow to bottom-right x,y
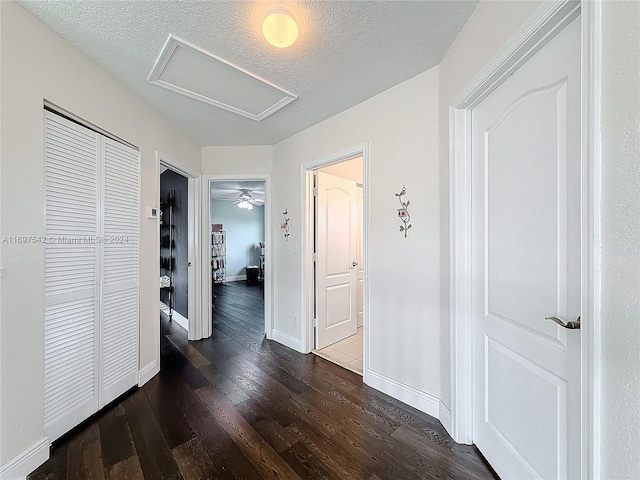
44,112 -> 99,441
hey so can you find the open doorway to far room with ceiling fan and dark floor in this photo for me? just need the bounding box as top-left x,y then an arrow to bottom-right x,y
209,179 -> 268,338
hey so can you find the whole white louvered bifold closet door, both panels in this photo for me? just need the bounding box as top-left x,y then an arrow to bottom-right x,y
44,111 -> 140,441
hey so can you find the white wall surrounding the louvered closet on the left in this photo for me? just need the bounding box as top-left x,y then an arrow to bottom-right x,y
0,1 -> 200,465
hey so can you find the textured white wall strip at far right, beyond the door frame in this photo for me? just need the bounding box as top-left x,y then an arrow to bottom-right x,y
601,1 -> 640,479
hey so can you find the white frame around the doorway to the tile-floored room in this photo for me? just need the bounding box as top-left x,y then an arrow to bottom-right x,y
300,143 -> 370,376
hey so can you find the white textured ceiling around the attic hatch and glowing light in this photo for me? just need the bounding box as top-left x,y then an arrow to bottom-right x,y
20,0 -> 477,145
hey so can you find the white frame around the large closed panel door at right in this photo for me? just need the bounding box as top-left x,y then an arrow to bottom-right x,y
449,0 -> 601,478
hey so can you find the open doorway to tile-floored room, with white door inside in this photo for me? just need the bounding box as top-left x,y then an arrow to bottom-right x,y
310,155 -> 364,375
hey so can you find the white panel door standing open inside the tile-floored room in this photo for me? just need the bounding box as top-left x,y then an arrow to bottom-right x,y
316,172 -> 358,349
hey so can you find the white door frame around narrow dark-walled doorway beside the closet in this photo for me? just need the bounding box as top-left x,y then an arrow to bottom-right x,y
156,150 -> 203,342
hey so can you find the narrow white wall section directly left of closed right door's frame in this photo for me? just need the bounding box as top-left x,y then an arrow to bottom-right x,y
439,0 -> 542,407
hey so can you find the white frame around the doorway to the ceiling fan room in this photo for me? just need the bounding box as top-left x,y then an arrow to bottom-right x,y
201,173 -> 273,340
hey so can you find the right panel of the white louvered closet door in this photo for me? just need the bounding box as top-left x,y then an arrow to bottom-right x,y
99,137 -> 140,408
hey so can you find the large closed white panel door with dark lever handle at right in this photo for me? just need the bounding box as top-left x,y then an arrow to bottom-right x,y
472,19 -> 581,479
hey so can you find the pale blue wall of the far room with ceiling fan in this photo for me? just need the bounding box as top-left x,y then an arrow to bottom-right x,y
211,200 -> 264,281
